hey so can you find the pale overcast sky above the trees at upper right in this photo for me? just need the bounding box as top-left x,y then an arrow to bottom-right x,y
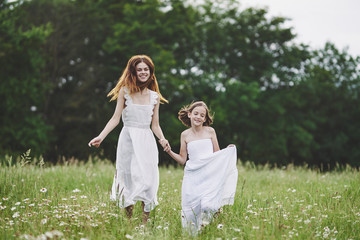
239,0 -> 360,56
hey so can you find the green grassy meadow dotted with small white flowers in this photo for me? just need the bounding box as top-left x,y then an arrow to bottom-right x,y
0,153 -> 360,240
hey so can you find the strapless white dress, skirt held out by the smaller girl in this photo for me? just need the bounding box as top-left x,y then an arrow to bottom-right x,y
181,139 -> 238,233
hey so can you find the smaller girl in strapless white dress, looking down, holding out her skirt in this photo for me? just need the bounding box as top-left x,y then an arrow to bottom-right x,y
166,101 -> 238,234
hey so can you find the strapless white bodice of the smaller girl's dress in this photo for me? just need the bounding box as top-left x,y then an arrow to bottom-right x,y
187,138 -> 214,160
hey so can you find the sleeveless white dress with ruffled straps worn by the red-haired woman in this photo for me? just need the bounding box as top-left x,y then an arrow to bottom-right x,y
110,89 -> 159,212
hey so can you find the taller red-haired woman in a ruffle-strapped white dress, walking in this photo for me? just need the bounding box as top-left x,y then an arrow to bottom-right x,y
89,55 -> 169,223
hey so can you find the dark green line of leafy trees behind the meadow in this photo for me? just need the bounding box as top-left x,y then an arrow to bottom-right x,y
0,0 -> 360,169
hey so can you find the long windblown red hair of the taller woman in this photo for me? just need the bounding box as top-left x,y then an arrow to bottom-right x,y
107,55 -> 168,103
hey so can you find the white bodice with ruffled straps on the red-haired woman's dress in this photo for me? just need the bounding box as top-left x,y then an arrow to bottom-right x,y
122,89 -> 159,128
